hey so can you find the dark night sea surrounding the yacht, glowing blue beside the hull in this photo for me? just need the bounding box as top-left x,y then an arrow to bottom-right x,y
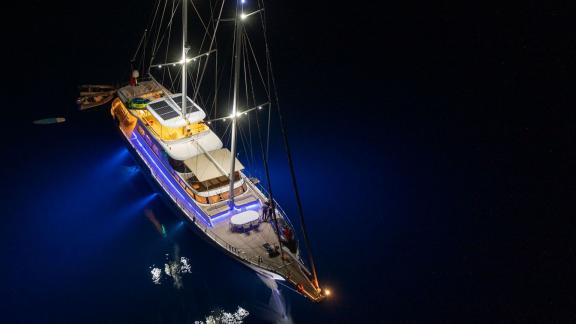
0,0 -> 576,323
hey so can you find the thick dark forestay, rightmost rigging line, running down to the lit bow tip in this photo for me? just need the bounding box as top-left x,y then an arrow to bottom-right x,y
262,1 -> 320,289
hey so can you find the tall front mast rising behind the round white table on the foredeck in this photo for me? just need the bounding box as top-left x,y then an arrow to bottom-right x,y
229,0 -> 242,207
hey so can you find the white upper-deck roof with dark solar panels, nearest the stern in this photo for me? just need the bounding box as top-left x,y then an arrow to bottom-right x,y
146,93 -> 206,128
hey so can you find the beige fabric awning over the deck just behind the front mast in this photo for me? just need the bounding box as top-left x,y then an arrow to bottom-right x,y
184,148 -> 244,182
